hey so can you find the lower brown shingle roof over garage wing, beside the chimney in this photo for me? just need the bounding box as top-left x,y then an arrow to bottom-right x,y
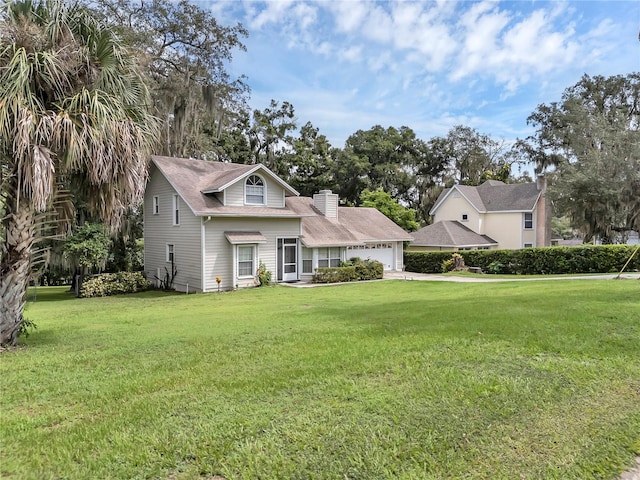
287,197 -> 412,248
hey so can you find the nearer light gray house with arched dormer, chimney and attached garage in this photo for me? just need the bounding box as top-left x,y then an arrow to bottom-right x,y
144,156 -> 411,292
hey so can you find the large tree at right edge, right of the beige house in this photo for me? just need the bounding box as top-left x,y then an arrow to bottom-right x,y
526,73 -> 640,243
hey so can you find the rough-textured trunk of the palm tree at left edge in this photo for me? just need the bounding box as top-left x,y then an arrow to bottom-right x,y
0,200 -> 35,345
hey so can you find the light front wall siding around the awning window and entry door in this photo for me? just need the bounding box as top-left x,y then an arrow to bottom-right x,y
204,217 -> 302,291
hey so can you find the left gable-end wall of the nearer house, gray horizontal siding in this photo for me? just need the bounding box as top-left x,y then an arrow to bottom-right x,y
144,167 -> 202,291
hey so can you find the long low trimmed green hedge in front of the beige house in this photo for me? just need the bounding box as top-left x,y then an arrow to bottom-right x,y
404,245 -> 640,275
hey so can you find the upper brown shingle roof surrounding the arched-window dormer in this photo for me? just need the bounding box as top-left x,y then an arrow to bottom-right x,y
151,155 -> 298,217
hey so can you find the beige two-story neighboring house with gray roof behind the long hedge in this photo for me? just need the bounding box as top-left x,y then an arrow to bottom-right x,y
407,176 -> 551,251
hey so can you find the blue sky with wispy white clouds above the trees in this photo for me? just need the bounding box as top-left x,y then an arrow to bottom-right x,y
205,0 -> 640,147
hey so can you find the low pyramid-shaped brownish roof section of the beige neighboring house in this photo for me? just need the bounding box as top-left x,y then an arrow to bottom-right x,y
411,220 -> 498,247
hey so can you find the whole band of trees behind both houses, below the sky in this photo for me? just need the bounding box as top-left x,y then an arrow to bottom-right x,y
81,0 -> 640,242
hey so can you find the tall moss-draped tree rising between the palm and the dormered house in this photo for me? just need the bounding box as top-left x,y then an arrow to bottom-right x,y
86,0 -> 249,159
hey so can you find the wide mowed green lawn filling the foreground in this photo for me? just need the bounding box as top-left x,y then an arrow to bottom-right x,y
0,280 -> 640,480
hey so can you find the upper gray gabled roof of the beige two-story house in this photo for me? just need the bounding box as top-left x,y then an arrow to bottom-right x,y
429,180 -> 541,215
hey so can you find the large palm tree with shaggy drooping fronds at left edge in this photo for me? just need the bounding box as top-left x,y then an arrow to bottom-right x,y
0,0 -> 157,344
